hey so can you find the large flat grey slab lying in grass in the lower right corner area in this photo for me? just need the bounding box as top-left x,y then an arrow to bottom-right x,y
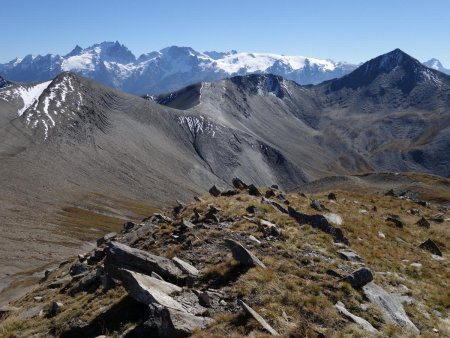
363,282 -> 420,334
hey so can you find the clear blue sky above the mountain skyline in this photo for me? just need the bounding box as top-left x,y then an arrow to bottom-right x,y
0,0 -> 450,68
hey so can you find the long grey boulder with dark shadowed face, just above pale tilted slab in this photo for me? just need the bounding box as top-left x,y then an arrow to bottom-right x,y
105,242 -> 186,281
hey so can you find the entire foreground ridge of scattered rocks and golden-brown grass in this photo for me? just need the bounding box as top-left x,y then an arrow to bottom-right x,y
0,178 -> 450,337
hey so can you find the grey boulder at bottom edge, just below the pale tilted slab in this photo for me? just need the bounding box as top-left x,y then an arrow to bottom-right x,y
158,308 -> 214,338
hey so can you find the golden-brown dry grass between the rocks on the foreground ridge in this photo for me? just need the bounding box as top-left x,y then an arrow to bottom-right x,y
0,186 -> 450,337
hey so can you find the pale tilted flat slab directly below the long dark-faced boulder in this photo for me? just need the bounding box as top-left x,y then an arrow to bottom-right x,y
119,269 -> 186,312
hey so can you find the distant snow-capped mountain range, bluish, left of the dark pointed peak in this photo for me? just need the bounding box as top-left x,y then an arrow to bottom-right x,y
0,42 -> 356,95
